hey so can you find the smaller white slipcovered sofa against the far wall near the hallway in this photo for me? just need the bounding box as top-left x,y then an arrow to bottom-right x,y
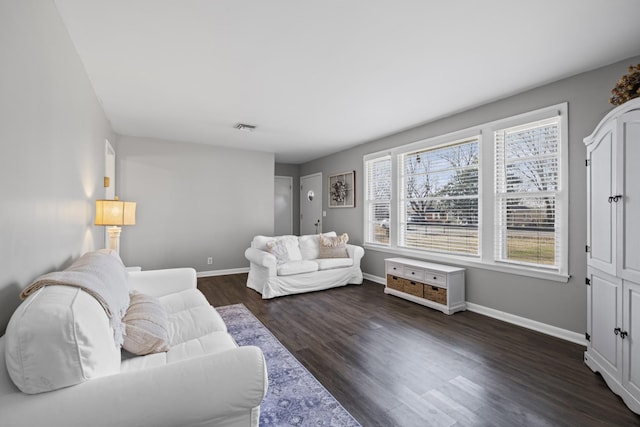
245,231 -> 364,299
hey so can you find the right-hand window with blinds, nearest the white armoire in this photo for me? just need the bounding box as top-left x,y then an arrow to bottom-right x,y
494,117 -> 561,268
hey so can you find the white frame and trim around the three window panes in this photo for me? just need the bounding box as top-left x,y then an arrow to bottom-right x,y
363,102 -> 570,282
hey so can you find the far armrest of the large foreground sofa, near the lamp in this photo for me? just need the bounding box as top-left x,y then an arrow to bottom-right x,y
129,268 -> 198,297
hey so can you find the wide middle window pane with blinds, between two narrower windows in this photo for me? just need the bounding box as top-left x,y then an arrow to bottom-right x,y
399,139 -> 478,255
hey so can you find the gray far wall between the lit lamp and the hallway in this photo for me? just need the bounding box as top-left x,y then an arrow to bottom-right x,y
116,136 -> 274,271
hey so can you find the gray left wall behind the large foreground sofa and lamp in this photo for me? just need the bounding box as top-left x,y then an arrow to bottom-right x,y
0,0 -> 112,334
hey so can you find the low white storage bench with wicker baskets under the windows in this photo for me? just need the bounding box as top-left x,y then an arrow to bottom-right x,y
384,258 -> 467,314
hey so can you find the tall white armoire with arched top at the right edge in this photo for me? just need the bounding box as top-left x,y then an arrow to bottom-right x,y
584,98 -> 640,413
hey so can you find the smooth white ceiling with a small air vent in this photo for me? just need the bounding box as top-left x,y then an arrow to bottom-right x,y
54,0 -> 640,163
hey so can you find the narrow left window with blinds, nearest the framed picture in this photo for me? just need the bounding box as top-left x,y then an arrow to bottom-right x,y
365,156 -> 392,244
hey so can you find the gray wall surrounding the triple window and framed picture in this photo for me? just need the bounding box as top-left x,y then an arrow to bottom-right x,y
300,57 -> 640,333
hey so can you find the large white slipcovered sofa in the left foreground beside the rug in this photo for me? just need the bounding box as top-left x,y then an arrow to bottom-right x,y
0,251 -> 267,427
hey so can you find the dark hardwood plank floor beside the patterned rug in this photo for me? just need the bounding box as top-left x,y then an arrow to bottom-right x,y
198,274 -> 640,427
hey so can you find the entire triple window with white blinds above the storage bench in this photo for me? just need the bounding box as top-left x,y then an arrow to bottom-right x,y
363,103 -> 569,282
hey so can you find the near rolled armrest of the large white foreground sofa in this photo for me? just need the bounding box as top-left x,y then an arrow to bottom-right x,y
0,346 -> 267,427
